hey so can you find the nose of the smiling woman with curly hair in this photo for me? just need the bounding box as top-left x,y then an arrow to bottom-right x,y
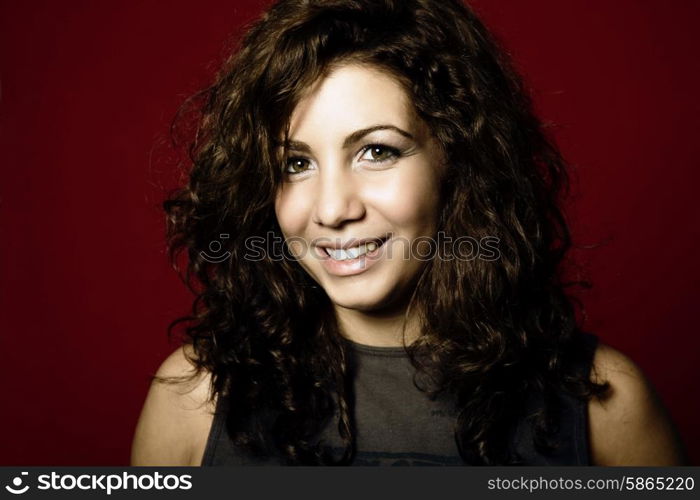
313,165 -> 365,227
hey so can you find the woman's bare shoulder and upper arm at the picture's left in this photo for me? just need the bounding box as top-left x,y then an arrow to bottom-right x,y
131,345 -> 216,465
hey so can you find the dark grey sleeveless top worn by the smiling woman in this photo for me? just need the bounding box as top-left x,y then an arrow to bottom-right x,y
202,334 -> 597,466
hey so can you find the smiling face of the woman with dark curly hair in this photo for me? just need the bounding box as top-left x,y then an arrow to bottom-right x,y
275,64 -> 442,311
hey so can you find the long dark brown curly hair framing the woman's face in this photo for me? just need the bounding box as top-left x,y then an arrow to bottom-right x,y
164,0 -> 607,465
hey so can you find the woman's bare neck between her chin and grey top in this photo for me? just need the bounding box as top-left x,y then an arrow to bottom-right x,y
335,300 -> 420,347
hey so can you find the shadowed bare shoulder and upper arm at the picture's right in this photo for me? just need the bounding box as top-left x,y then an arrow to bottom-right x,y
588,344 -> 686,466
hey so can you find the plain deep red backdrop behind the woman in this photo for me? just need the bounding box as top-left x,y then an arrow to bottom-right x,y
0,0 -> 700,465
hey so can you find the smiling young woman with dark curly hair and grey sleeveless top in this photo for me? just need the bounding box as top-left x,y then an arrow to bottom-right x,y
132,0 -> 684,465
